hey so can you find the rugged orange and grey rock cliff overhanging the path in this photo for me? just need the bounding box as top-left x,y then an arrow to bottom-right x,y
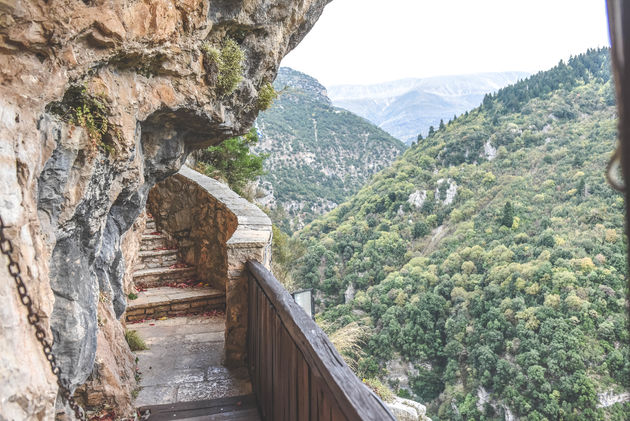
0,0 -> 328,419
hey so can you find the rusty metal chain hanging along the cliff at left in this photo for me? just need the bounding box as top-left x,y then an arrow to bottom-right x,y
0,216 -> 86,421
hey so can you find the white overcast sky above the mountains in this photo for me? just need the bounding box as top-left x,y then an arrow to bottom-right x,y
282,0 -> 610,86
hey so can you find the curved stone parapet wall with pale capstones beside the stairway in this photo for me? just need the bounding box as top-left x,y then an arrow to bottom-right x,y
147,166 -> 272,366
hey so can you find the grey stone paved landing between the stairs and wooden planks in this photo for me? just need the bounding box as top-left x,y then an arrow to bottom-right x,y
132,315 -> 252,407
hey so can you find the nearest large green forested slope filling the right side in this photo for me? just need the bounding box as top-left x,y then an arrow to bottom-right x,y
293,49 -> 630,420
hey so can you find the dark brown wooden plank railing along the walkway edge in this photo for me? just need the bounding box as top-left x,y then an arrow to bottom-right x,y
247,261 -> 395,421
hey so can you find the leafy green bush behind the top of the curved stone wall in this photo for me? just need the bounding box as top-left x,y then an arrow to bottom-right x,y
197,128 -> 268,195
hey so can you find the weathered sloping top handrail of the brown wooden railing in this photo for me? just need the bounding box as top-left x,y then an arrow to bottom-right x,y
247,261 -> 396,421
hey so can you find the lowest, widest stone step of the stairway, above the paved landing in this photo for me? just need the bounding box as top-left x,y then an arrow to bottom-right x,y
125,287 -> 225,322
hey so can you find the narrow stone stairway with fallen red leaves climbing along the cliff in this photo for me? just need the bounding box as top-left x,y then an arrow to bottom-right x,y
125,217 -> 225,322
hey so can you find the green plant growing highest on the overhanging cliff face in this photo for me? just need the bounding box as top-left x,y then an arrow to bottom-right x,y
201,38 -> 245,95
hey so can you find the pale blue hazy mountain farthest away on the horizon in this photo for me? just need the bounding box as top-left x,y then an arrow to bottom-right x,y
329,72 -> 528,144
